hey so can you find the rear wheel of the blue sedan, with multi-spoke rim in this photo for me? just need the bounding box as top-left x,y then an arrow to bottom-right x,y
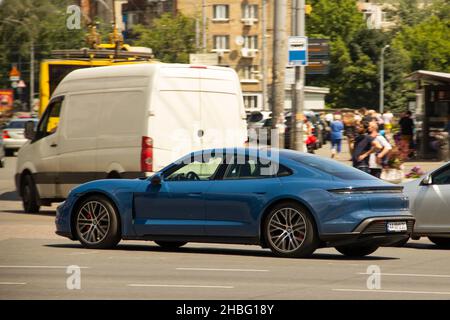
263,202 -> 319,258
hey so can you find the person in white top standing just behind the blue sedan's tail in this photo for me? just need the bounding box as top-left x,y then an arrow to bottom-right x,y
369,122 -> 392,178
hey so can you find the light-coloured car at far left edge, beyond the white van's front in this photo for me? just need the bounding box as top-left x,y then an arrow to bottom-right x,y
2,118 -> 38,157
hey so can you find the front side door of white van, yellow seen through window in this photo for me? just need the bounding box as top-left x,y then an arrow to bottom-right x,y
30,96 -> 64,199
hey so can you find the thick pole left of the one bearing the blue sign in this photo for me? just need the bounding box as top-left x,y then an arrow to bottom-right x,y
272,0 -> 287,148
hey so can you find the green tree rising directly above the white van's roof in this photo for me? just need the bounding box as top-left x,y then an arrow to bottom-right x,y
133,13 -> 196,63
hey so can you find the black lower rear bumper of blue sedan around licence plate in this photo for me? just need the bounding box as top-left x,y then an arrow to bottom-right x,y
320,216 -> 415,247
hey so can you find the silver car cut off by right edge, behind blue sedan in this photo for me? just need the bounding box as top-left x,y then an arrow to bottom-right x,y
402,162 -> 450,247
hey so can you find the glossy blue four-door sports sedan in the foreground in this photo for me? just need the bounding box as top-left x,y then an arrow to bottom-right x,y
56,148 -> 415,257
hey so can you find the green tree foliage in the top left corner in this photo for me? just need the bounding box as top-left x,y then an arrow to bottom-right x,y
0,0 -> 86,87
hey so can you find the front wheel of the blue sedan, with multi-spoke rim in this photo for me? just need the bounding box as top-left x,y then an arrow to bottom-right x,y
72,196 -> 121,249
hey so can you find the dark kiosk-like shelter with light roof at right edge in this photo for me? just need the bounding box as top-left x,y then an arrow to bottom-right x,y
406,70 -> 450,160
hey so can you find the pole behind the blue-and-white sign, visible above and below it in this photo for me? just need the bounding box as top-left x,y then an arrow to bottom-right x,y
291,0 -> 305,151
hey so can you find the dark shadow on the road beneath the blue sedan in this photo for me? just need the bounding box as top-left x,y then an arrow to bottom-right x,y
45,243 -> 398,261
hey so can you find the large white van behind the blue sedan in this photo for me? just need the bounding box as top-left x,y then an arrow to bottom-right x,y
15,64 -> 247,212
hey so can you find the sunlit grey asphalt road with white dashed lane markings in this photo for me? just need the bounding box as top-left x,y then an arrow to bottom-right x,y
0,158 -> 450,300
